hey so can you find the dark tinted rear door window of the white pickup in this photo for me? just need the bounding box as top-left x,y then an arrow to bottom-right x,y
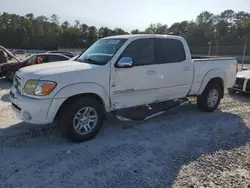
155,38 -> 186,64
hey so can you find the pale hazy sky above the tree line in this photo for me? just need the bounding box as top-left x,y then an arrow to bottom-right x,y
0,0 -> 250,31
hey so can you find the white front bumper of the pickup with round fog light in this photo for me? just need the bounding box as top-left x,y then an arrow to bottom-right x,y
10,86 -> 64,124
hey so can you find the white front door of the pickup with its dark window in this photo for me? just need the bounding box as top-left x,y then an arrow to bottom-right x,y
110,38 -> 157,109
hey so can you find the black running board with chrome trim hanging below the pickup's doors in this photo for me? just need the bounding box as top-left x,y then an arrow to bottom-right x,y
114,98 -> 190,122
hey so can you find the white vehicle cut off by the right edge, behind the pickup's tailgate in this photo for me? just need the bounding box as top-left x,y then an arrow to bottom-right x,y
228,70 -> 250,94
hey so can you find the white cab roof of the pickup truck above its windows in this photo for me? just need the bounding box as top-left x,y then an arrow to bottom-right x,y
103,34 -> 183,40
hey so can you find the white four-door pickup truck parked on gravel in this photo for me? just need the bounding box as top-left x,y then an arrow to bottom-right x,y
10,35 -> 236,142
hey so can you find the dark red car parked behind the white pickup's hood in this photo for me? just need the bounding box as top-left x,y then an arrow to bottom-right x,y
0,53 -> 69,81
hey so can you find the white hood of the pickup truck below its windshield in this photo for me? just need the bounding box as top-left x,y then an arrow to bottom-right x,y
18,60 -> 99,76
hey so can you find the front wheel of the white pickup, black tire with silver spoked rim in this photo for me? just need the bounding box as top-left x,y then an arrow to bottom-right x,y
58,97 -> 104,142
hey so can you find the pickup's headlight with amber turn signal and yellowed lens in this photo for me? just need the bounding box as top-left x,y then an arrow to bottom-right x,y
23,80 -> 56,96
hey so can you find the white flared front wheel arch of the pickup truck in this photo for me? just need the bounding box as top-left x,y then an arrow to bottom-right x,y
54,83 -> 110,111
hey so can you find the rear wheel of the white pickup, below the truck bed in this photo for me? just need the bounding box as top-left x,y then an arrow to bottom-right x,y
197,83 -> 223,112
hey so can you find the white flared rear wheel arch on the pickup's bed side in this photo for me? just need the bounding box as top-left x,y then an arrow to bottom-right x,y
197,69 -> 226,95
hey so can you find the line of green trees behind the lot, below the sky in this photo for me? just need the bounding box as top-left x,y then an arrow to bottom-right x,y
0,10 -> 250,49
